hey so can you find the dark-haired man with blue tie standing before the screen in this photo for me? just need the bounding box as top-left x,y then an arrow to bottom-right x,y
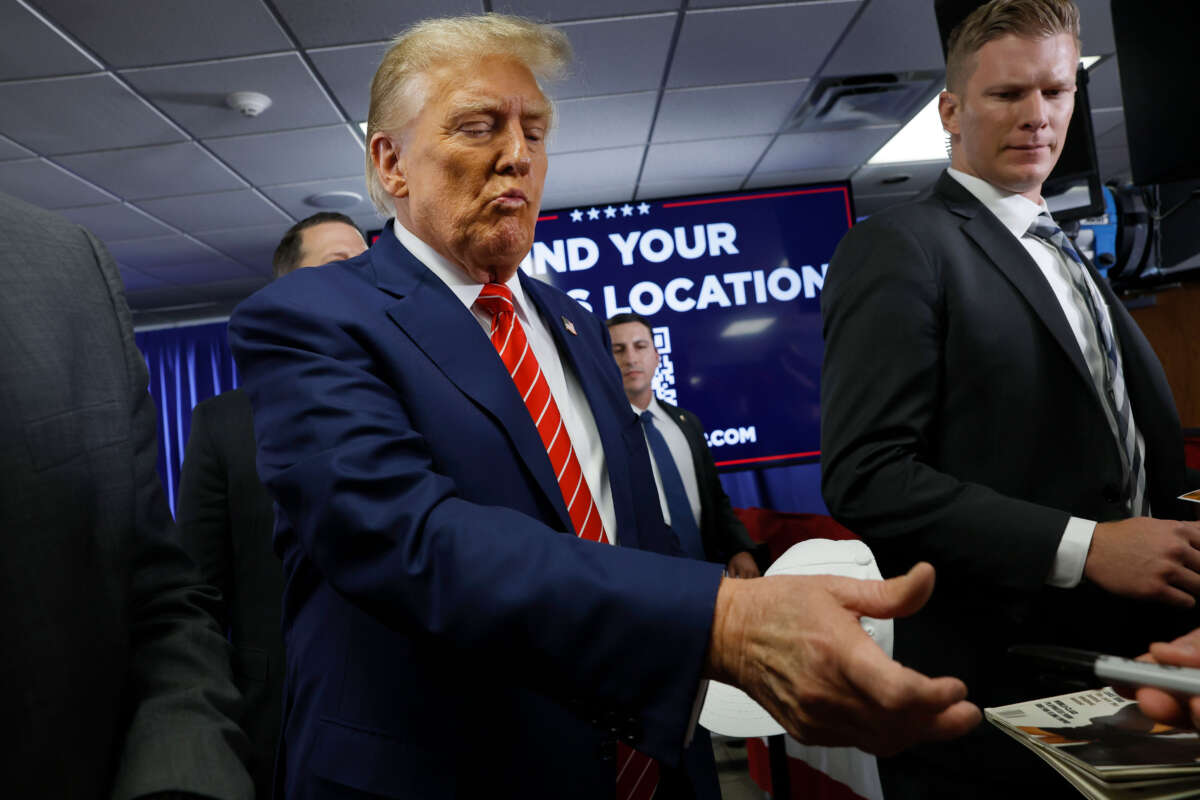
607,313 -> 766,578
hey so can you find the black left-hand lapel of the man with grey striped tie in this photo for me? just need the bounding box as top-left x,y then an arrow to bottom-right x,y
935,173 -> 1096,395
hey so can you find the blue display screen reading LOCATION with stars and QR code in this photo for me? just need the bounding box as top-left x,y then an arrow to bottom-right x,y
521,184 -> 853,469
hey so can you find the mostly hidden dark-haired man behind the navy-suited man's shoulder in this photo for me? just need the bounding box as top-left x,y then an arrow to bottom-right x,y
178,211 -> 366,798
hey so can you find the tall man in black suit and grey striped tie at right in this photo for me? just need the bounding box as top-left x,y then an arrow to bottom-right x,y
822,0 -> 1200,798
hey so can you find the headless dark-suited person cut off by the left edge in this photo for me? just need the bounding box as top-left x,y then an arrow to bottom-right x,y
0,194 -> 252,800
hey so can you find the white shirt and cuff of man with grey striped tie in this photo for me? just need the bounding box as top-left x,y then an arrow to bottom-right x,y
946,168 -> 1141,589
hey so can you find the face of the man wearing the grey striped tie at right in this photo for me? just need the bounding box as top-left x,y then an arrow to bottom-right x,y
940,34 -> 1079,201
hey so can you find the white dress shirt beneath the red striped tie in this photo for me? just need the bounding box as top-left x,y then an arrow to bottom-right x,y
394,219 -> 617,545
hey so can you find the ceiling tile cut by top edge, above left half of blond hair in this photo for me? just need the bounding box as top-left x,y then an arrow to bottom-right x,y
275,0 -> 484,47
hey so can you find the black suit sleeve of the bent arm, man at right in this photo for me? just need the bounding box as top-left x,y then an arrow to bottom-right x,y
821,218 -> 1069,591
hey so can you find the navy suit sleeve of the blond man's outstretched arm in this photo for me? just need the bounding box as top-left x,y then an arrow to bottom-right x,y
229,283 -> 720,759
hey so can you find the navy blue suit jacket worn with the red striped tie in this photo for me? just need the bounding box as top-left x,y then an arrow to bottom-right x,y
229,224 -> 720,799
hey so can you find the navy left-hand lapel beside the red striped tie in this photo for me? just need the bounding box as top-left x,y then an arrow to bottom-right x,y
371,222 -> 572,530
